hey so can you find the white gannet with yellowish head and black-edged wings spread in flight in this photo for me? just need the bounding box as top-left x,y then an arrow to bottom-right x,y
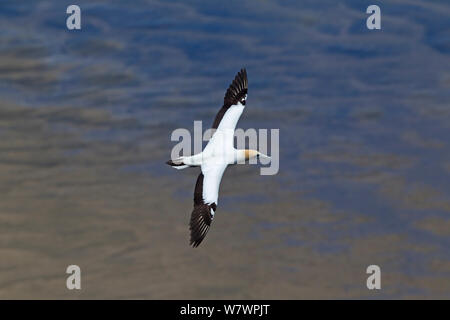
166,69 -> 270,248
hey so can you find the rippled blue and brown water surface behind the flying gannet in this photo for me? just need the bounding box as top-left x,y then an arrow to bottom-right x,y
0,0 -> 450,299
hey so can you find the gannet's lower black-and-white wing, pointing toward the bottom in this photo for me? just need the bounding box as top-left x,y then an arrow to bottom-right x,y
189,164 -> 227,247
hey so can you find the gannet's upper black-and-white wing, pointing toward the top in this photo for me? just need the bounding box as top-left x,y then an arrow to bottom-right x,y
212,69 -> 248,130
